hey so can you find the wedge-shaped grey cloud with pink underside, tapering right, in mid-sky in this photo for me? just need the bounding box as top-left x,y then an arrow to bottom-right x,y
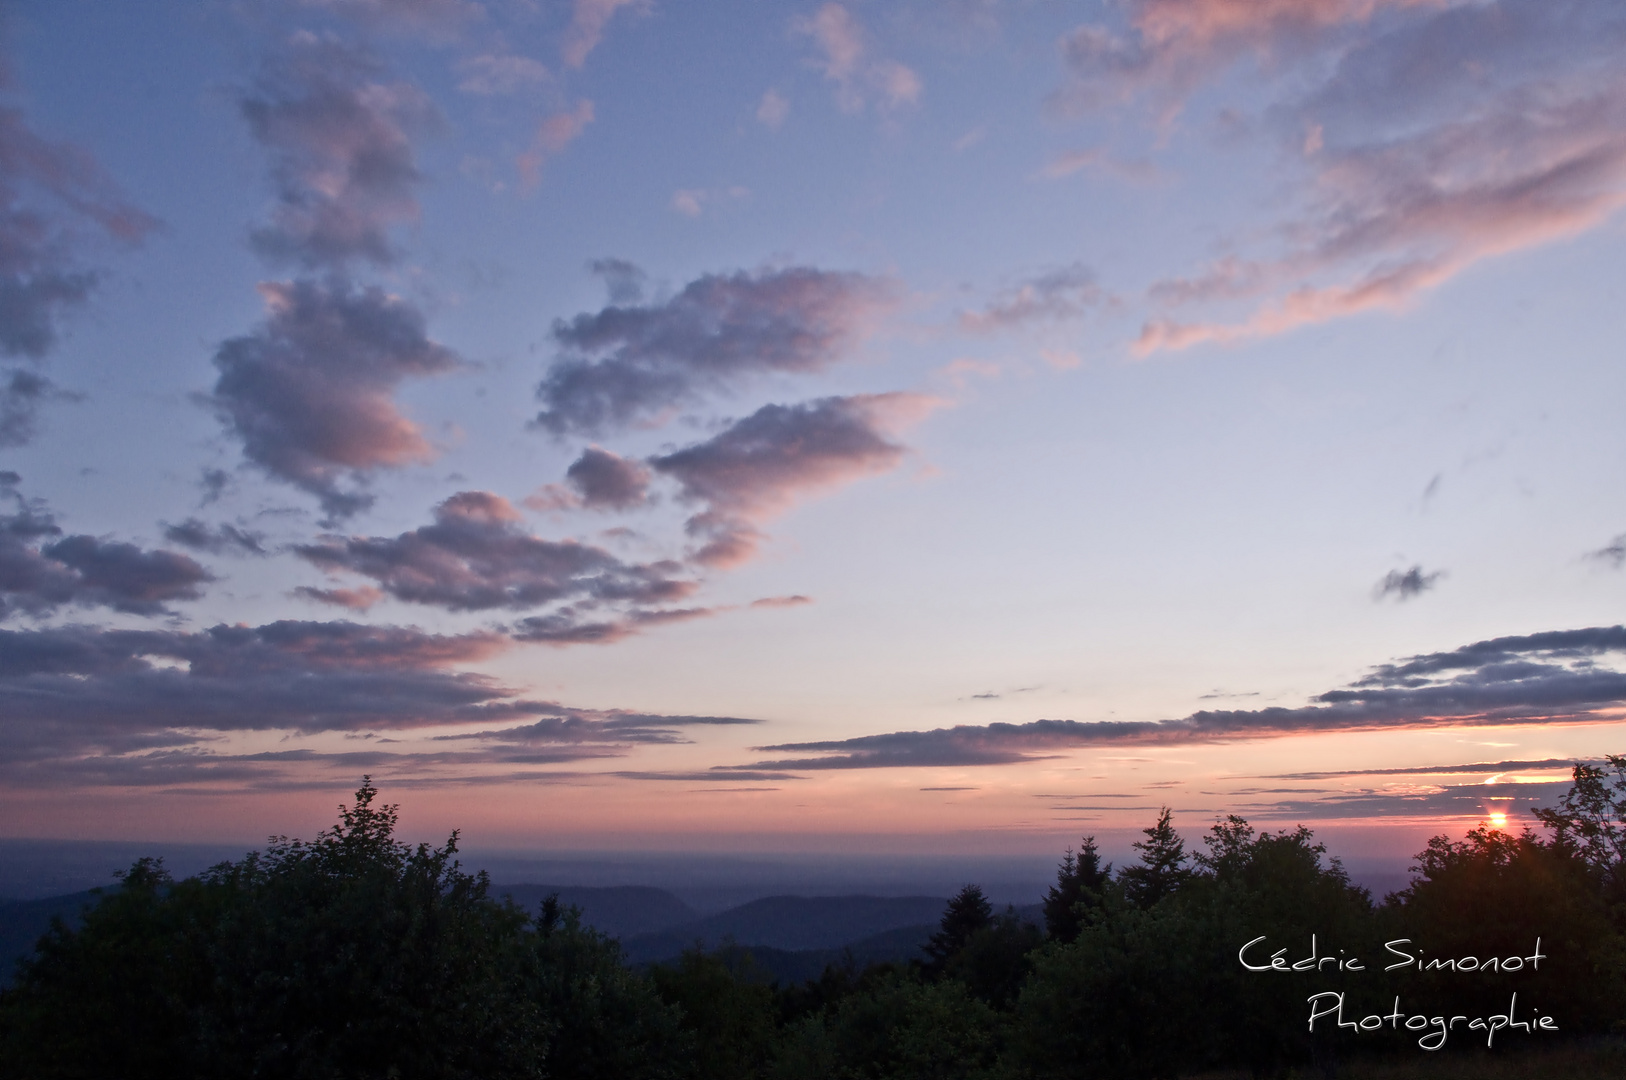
649,394 -> 937,566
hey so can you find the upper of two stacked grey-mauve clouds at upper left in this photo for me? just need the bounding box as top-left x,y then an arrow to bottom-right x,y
241,34 -> 437,270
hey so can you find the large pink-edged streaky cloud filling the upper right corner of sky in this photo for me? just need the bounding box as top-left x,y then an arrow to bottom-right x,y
1137,0 -> 1626,355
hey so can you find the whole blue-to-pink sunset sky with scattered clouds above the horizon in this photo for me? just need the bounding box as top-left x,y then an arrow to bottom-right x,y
0,0 -> 1626,857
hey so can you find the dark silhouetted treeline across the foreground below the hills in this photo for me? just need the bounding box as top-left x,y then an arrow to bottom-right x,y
0,756 -> 1626,1080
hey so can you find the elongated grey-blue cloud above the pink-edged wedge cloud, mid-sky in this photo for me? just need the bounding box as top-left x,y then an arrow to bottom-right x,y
537,260 -> 898,434
